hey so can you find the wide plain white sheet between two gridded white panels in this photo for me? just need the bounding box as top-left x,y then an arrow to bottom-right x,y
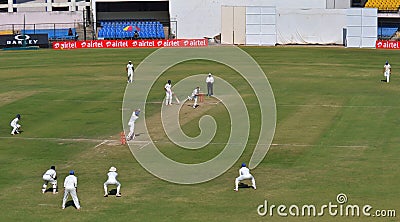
276,9 -> 346,44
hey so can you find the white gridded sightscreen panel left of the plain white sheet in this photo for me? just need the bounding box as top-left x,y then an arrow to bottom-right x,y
246,7 -> 276,45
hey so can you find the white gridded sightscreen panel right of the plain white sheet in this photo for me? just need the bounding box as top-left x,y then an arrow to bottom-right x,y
346,8 -> 378,48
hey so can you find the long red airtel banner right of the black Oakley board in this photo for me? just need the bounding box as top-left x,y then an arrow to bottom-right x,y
53,39 -> 208,50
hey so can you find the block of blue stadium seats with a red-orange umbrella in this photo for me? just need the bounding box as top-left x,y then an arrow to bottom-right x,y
98,20 -> 165,39
